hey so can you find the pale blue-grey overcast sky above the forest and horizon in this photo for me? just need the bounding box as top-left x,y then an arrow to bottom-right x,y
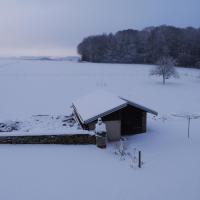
0,0 -> 200,56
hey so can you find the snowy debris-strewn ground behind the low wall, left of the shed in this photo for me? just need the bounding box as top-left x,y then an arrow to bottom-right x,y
0,115 -> 94,136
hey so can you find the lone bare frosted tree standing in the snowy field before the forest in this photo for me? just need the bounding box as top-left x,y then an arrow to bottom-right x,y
150,56 -> 179,84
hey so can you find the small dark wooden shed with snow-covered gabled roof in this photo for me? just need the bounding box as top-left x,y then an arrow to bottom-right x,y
72,90 -> 158,141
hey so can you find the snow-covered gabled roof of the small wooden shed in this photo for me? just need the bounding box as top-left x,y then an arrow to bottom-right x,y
72,90 -> 157,123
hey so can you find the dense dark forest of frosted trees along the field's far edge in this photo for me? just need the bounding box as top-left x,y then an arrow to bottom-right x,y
77,25 -> 200,68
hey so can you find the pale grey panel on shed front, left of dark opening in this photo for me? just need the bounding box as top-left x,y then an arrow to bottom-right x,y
105,120 -> 121,141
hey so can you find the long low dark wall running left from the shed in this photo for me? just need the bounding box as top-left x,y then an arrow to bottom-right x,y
0,134 -> 96,144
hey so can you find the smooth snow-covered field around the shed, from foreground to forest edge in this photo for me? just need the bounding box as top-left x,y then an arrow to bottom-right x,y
0,59 -> 200,200
